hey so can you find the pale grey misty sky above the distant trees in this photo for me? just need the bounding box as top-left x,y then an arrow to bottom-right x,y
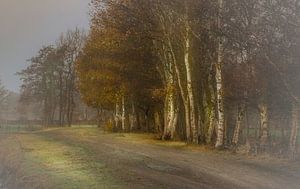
0,0 -> 90,91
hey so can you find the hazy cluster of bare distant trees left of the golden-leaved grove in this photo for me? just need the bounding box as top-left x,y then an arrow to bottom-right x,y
18,29 -> 86,126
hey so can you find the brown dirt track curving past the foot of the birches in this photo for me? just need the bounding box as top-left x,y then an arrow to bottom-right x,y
0,129 -> 300,189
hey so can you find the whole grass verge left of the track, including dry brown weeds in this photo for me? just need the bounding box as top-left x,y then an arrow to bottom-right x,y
0,132 -> 120,189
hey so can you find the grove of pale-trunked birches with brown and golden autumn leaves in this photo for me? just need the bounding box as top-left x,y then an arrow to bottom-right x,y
78,0 -> 299,157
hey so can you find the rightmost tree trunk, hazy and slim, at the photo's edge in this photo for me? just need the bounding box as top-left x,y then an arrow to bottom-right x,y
289,103 -> 299,159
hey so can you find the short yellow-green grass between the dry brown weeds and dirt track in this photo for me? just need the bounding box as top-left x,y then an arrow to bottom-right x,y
11,131 -> 118,189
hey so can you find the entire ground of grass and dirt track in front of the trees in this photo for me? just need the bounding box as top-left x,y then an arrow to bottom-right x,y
0,127 -> 300,189
